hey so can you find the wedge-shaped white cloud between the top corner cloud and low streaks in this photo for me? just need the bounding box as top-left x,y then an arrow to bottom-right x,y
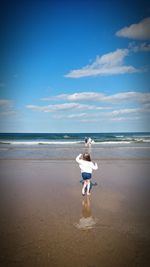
65,49 -> 141,78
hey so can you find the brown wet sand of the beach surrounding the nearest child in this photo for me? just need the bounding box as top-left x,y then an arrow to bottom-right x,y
0,160 -> 150,267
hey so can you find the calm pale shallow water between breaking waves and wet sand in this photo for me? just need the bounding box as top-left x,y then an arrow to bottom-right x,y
0,144 -> 150,160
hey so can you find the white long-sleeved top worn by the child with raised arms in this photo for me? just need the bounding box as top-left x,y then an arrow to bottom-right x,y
76,154 -> 98,173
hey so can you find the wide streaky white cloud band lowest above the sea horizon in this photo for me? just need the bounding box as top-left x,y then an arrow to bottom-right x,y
26,91 -> 150,127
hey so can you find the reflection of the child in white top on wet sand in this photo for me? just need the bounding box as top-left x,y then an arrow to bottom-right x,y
75,196 -> 96,230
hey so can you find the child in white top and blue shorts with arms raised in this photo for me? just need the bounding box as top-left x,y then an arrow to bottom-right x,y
76,153 -> 98,196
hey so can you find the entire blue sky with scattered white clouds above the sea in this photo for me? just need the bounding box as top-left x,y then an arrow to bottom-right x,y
0,0 -> 150,133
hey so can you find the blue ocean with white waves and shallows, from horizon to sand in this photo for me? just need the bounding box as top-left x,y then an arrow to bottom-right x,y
0,132 -> 150,160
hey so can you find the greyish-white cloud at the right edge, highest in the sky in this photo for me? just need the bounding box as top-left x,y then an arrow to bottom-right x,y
116,17 -> 150,40
